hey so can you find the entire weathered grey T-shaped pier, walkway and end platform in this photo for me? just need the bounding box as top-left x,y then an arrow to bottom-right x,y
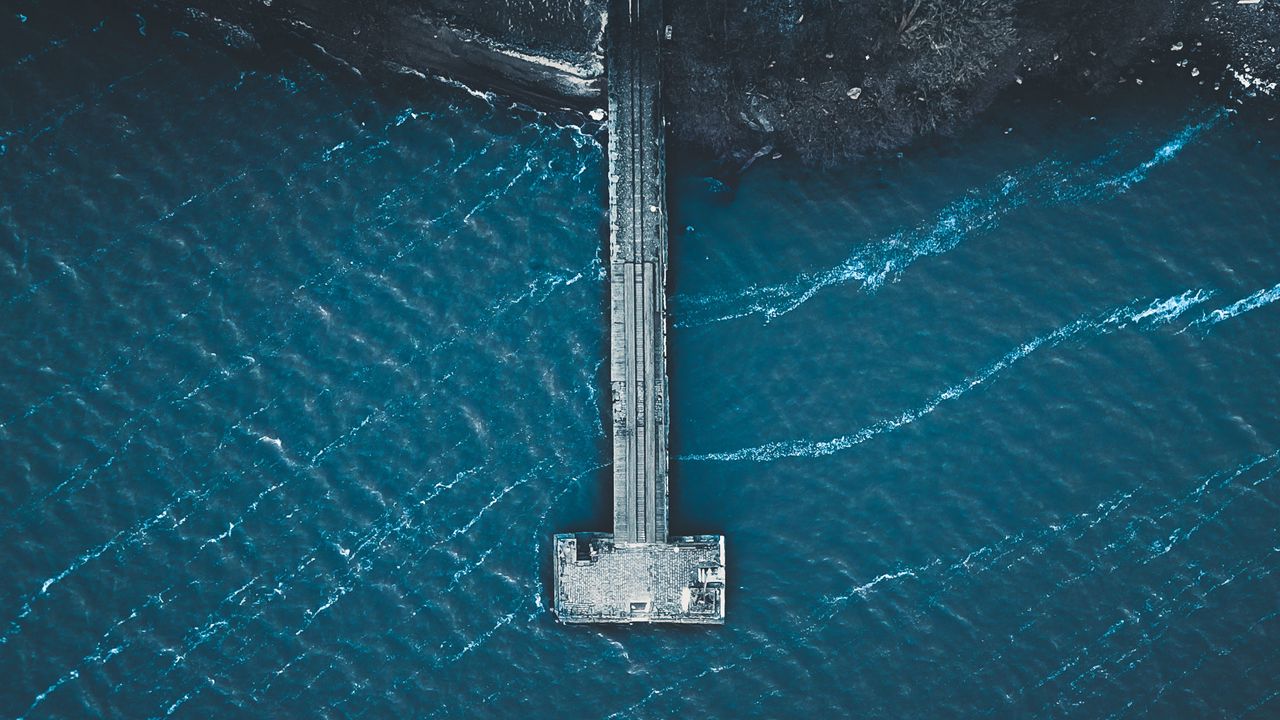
554,0 -> 724,624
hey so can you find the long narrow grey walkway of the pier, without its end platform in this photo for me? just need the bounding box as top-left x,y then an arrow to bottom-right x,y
608,0 -> 668,542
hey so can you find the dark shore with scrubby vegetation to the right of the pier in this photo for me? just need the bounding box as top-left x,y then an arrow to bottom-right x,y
664,0 -> 1280,165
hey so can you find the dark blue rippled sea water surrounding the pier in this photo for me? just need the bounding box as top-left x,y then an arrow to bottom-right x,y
0,3 -> 1280,719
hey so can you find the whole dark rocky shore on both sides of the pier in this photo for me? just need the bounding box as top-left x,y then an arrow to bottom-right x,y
143,0 -> 1280,167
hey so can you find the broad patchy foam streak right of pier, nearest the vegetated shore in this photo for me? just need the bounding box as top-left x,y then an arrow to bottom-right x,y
676,109 -> 1230,328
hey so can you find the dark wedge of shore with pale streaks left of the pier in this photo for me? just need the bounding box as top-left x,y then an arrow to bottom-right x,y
142,0 -> 605,108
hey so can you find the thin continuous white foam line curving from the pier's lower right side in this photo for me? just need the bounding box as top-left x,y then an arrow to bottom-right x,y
681,290 -> 1212,462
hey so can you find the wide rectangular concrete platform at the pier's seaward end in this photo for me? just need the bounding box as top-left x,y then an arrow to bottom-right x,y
556,533 -> 724,624
